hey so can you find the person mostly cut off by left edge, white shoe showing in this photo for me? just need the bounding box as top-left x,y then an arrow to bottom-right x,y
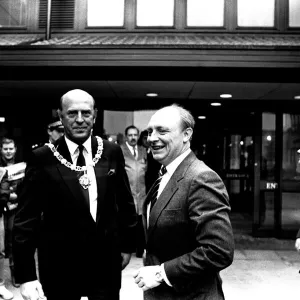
0,167 -> 14,300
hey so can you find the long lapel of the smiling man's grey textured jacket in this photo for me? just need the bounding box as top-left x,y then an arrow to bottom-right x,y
147,152 -> 196,238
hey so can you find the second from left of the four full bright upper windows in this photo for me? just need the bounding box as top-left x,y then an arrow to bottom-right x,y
136,0 -> 174,27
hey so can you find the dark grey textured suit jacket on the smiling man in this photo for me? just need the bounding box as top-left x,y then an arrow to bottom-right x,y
143,152 -> 234,300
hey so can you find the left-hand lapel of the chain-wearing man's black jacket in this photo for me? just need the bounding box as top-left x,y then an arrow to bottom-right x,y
57,138 -> 89,210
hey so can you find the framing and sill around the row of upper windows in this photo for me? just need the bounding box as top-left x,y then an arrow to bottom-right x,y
0,0 -> 300,34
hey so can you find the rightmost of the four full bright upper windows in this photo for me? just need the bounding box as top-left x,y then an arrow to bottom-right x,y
237,0 -> 275,27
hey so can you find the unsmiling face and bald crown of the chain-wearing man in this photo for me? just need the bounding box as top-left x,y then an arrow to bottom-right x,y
58,90 -> 97,144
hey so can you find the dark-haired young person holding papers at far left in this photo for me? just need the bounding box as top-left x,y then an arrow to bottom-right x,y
0,137 -> 26,287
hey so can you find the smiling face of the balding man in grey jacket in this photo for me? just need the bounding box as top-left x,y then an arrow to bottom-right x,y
147,106 -> 193,166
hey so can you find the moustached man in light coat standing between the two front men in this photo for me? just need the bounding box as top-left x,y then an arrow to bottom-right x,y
121,125 -> 147,257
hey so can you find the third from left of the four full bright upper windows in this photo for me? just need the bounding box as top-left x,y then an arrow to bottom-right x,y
187,0 -> 224,27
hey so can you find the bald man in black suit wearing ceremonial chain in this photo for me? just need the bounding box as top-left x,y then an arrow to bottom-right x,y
13,89 -> 137,300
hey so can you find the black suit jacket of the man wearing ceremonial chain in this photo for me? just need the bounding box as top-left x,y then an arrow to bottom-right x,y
13,137 -> 136,295
